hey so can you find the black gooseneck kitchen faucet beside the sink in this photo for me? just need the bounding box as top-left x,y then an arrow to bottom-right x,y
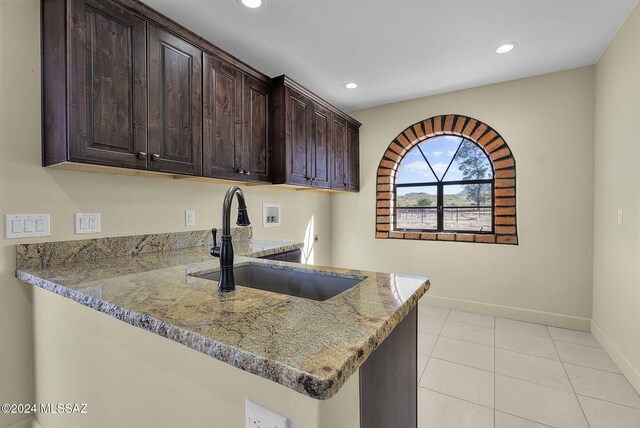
211,186 -> 251,293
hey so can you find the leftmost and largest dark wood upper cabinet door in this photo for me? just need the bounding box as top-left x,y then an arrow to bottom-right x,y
68,0 -> 147,169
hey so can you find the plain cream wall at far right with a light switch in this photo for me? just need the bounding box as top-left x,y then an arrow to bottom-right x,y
593,1 -> 640,391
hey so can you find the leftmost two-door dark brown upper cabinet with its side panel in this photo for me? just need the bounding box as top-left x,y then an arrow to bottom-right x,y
42,0 -> 202,175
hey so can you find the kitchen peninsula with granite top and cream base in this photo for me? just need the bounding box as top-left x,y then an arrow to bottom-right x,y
17,229 -> 429,427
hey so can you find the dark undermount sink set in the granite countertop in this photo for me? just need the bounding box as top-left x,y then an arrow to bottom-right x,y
196,263 -> 364,301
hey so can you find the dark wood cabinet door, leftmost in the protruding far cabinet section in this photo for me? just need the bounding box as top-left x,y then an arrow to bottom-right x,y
285,88 -> 313,185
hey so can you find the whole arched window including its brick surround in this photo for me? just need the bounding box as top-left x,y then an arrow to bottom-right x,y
376,115 -> 518,244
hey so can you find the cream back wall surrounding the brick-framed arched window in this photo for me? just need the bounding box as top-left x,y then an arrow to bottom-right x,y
332,67 -> 594,329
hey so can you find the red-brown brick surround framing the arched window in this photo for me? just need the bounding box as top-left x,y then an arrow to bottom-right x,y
376,114 -> 518,245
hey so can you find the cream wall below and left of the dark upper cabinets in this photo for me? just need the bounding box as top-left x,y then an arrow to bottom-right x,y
0,0 -> 331,427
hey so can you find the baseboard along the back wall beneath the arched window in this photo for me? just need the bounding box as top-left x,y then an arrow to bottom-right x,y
418,294 -> 591,331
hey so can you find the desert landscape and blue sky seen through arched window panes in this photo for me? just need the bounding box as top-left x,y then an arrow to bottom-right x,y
395,135 -> 493,233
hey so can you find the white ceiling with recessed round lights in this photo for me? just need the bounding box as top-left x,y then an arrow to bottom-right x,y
143,0 -> 638,111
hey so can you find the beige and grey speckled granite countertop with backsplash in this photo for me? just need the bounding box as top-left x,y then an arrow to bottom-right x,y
16,231 -> 429,399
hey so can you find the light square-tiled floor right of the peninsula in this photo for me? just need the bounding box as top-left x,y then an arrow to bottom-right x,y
418,305 -> 640,428
